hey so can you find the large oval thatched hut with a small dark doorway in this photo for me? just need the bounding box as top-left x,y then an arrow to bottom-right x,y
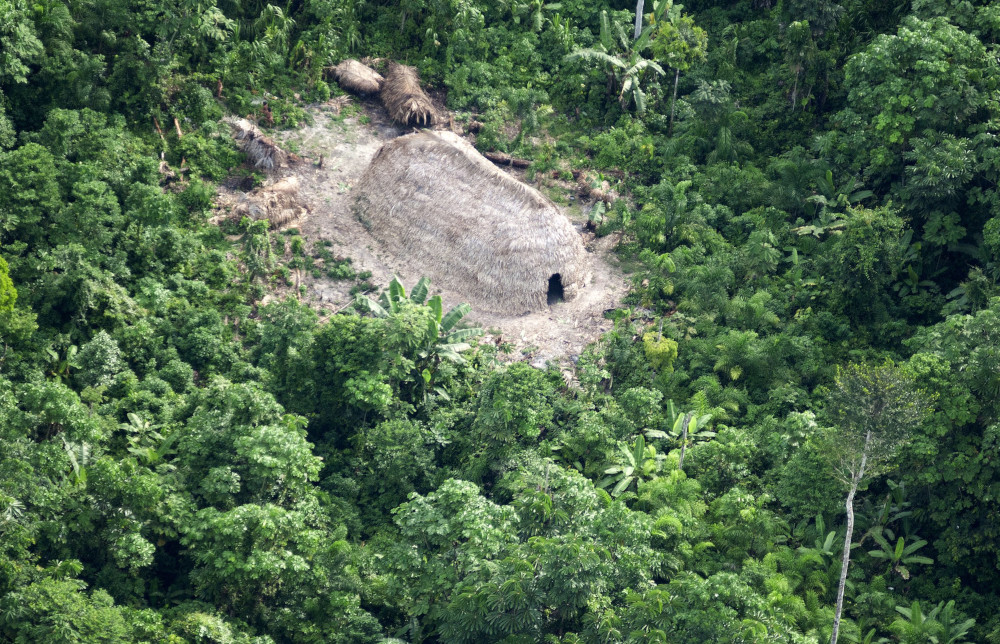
355,130 -> 587,313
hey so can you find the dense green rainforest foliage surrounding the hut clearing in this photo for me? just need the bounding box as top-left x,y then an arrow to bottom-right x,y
0,0 -> 1000,644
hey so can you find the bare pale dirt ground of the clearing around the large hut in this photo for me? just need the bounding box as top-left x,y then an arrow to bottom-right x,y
223,97 -> 628,366
